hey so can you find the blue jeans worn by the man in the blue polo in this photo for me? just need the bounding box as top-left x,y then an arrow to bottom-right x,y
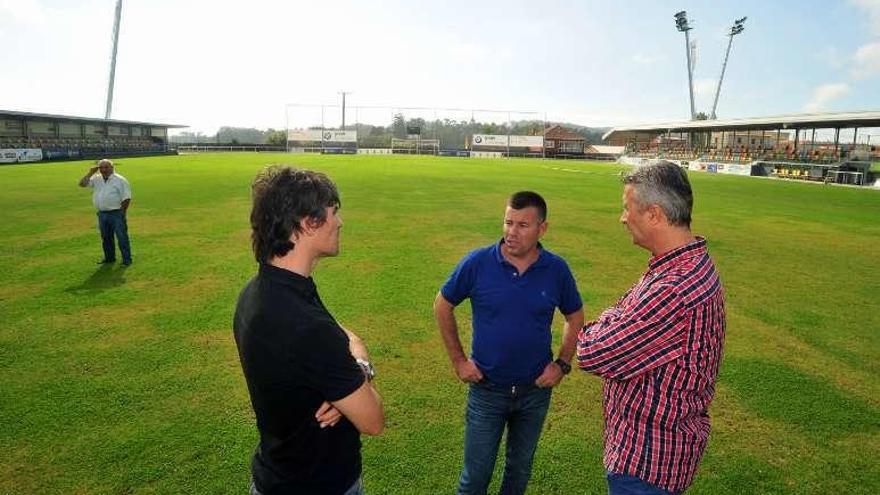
458,380 -> 552,495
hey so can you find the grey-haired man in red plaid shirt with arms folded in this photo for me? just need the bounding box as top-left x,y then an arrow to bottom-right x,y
577,162 -> 725,495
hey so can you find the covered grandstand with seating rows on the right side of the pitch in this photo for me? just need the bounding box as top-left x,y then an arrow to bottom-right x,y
603,111 -> 880,185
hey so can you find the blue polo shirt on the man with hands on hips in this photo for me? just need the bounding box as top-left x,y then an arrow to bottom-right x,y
440,240 -> 583,385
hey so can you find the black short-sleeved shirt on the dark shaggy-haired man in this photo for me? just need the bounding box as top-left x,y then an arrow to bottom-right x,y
233,264 -> 364,495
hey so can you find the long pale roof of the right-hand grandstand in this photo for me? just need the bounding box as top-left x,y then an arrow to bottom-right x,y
602,111 -> 880,140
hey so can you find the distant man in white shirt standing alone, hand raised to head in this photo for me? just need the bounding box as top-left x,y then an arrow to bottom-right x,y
79,159 -> 131,266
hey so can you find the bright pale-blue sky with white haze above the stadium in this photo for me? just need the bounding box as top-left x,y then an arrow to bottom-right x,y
0,0 -> 880,135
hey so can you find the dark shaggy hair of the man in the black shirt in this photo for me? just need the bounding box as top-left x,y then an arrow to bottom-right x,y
251,165 -> 342,263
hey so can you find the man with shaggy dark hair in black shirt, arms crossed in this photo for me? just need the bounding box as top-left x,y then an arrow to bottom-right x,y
233,166 -> 385,495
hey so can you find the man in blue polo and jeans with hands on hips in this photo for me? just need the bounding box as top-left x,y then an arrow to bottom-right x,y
434,191 -> 584,494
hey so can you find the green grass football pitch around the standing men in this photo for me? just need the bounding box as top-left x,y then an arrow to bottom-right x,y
0,154 -> 880,494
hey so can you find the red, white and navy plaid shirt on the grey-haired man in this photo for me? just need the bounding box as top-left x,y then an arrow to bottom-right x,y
577,237 -> 725,492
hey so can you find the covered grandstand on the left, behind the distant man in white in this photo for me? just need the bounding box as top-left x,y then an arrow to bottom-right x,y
0,110 -> 186,163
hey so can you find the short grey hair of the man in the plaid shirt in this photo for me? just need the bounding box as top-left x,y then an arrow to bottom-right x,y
622,161 -> 694,227
